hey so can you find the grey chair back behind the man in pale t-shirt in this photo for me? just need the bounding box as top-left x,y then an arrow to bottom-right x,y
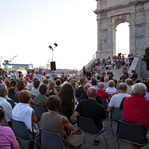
111,107 -> 122,122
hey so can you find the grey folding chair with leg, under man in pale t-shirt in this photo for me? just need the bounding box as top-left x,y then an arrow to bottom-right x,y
110,107 -> 123,136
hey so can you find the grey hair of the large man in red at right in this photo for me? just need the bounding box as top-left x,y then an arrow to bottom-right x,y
132,83 -> 147,96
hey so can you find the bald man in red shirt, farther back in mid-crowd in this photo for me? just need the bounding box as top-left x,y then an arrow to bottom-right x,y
97,82 -> 110,102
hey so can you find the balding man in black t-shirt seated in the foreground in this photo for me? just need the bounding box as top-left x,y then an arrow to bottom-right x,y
74,87 -> 106,145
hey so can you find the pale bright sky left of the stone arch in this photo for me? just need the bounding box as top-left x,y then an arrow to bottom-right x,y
0,0 -> 129,69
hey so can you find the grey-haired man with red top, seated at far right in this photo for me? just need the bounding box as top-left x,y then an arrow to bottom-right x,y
122,83 -> 149,139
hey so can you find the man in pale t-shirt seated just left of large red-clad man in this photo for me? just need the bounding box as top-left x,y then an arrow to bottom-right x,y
107,83 -> 130,112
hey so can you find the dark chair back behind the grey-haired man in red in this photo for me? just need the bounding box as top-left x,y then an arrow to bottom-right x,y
117,120 -> 147,145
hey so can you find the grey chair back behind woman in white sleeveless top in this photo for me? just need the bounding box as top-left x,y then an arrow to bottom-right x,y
12,120 -> 32,140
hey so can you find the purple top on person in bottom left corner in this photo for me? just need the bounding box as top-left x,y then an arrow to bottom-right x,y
0,126 -> 19,149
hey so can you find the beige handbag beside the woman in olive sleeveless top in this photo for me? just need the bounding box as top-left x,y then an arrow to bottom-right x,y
66,129 -> 84,147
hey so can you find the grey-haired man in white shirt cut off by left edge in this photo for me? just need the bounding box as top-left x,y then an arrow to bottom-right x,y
0,83 -> 12,125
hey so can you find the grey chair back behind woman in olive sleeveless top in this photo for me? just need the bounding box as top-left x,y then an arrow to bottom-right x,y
40,129 -> 64,149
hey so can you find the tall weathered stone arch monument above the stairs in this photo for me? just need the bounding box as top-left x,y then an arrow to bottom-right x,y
94,0 -> 149,58
